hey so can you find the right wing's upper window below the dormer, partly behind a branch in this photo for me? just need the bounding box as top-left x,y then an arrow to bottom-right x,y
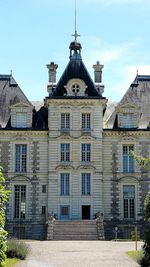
123,145 -> 134,172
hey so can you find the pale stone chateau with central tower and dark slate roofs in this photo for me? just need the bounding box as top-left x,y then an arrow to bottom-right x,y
0,35 -> 150,239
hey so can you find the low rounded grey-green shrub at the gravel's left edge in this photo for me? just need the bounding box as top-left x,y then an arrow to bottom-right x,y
6,239 -> 29,260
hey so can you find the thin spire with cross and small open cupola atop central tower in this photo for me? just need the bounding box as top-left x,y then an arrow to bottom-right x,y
69,0 -> 82,58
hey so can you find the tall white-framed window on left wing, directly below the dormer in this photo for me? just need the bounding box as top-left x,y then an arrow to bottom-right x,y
15,144 -> 27,172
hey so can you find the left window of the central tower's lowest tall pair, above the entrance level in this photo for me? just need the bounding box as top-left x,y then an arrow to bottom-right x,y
60,173 -> 70,196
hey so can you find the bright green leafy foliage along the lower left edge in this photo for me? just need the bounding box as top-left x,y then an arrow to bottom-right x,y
0,167 -> 9,267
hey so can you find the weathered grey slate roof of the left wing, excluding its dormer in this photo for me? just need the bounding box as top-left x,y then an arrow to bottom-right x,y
0,74 -> 31,127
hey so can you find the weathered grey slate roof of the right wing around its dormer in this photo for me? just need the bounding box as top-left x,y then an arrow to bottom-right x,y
106,75 -> 150,129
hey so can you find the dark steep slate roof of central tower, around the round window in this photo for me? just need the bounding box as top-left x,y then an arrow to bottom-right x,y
49,47 -> 103,98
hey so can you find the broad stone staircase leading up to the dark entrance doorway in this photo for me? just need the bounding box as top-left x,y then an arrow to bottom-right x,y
53,220 -> 98,240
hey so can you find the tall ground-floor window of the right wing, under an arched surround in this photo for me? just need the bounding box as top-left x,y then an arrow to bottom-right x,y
123,185 -> 135,219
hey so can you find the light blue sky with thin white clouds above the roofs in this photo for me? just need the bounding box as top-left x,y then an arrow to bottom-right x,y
0,0 -> 150,101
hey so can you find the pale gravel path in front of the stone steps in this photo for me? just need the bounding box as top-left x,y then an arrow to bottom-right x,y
16,241 -> 142,267
